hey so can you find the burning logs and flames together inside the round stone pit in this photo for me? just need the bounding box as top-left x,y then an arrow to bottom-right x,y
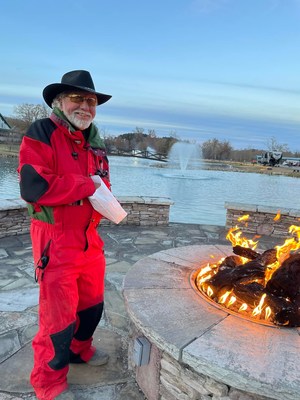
191,222 -> 300,327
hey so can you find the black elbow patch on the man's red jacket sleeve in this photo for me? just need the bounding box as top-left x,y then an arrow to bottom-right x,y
20,164 -> 49,203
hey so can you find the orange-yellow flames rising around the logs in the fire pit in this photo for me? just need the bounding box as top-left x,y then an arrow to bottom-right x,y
196,220 -> 300,326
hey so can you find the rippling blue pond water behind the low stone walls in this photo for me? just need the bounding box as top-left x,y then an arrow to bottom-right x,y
0,156 -> 300,226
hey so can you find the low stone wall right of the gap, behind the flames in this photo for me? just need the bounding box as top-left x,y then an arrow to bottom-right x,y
225,203 -> 300,238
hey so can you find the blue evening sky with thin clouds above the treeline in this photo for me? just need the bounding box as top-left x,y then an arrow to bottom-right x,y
0,0 -> 300,151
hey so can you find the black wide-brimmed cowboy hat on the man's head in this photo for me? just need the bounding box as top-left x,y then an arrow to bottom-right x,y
43,70 -> 111,107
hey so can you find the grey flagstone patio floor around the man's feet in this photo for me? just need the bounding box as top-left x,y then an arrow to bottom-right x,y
0,224 -> 241,400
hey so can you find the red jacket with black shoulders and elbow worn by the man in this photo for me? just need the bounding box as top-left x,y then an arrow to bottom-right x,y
18,114 -> 109,228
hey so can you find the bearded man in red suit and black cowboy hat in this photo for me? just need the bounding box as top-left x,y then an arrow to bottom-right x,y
18,70 -> 111,400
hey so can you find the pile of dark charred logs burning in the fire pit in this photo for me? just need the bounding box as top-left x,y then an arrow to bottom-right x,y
196,246 -> 300,327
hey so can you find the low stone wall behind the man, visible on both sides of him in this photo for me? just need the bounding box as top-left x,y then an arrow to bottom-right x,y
0,196 -> 173,238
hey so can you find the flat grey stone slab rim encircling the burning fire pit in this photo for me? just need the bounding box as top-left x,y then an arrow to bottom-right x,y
123,245 -> 300,400
